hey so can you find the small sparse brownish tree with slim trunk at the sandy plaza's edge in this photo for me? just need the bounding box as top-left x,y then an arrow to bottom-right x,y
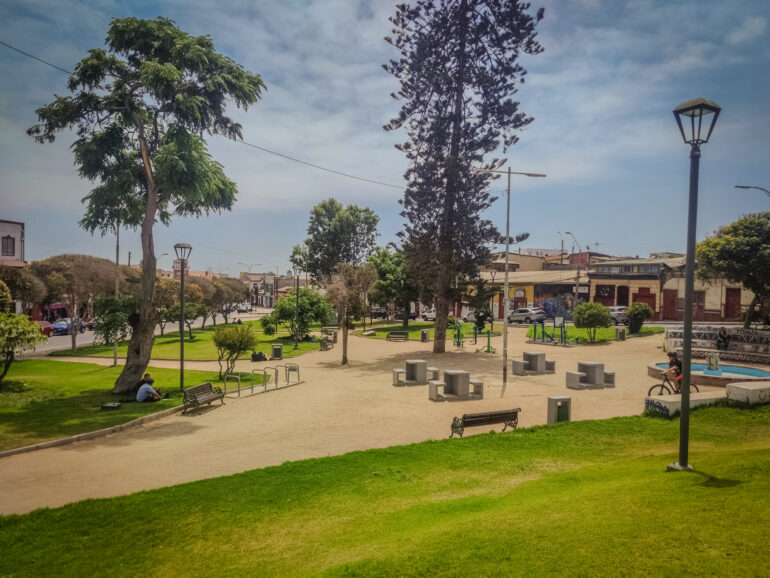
326,263 -> 377,365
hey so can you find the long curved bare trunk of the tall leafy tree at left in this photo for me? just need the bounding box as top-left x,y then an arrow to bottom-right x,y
112,117 -> 158,393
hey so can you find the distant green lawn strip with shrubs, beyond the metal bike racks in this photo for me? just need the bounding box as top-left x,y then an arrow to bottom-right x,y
51,321 -> 320,360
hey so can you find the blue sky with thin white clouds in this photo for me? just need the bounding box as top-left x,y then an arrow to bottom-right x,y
0,0 -> 770,275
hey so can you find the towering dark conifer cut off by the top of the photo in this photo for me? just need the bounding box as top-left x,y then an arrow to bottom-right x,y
385,0 -> 543,352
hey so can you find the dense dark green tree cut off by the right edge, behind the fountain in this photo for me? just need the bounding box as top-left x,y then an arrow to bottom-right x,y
696,212 -> 770,328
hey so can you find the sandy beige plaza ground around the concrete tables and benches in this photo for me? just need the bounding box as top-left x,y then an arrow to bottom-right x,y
0,327 -> 713,514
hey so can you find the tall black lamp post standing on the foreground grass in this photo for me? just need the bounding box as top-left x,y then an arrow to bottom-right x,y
668,98 -> 722,470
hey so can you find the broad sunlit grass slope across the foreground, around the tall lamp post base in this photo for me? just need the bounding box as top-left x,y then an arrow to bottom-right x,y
0,406 -> 770,576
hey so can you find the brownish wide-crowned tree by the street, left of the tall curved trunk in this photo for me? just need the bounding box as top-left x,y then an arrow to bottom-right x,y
31,254 -> 115,348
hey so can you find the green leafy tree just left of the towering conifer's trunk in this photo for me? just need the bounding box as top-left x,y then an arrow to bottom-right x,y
368,247 -> 420,328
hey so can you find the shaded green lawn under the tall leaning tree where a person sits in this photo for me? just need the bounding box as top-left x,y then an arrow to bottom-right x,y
0,359 -> 262,450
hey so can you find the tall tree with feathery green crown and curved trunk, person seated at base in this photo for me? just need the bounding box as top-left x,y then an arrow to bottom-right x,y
28,18 -> 265,393
